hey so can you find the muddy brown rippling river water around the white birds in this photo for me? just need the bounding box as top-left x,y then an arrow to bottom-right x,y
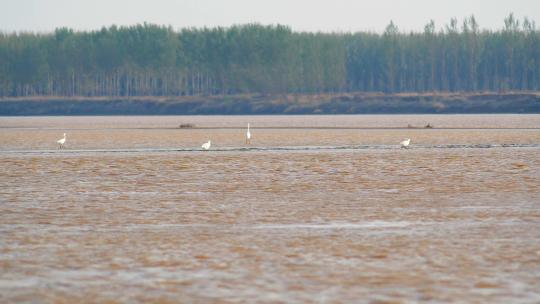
0,115 -> 540,303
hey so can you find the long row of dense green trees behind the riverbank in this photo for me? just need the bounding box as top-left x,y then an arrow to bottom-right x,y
0,14 -> 540,97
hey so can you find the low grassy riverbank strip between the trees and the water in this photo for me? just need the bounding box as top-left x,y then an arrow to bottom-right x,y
0,92 -> 540,116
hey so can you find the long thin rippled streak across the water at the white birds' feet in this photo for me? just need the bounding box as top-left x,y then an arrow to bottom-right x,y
0,144 -> 540,154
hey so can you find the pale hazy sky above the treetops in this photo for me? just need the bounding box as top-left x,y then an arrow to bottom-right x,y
0,0 -> 540,32
